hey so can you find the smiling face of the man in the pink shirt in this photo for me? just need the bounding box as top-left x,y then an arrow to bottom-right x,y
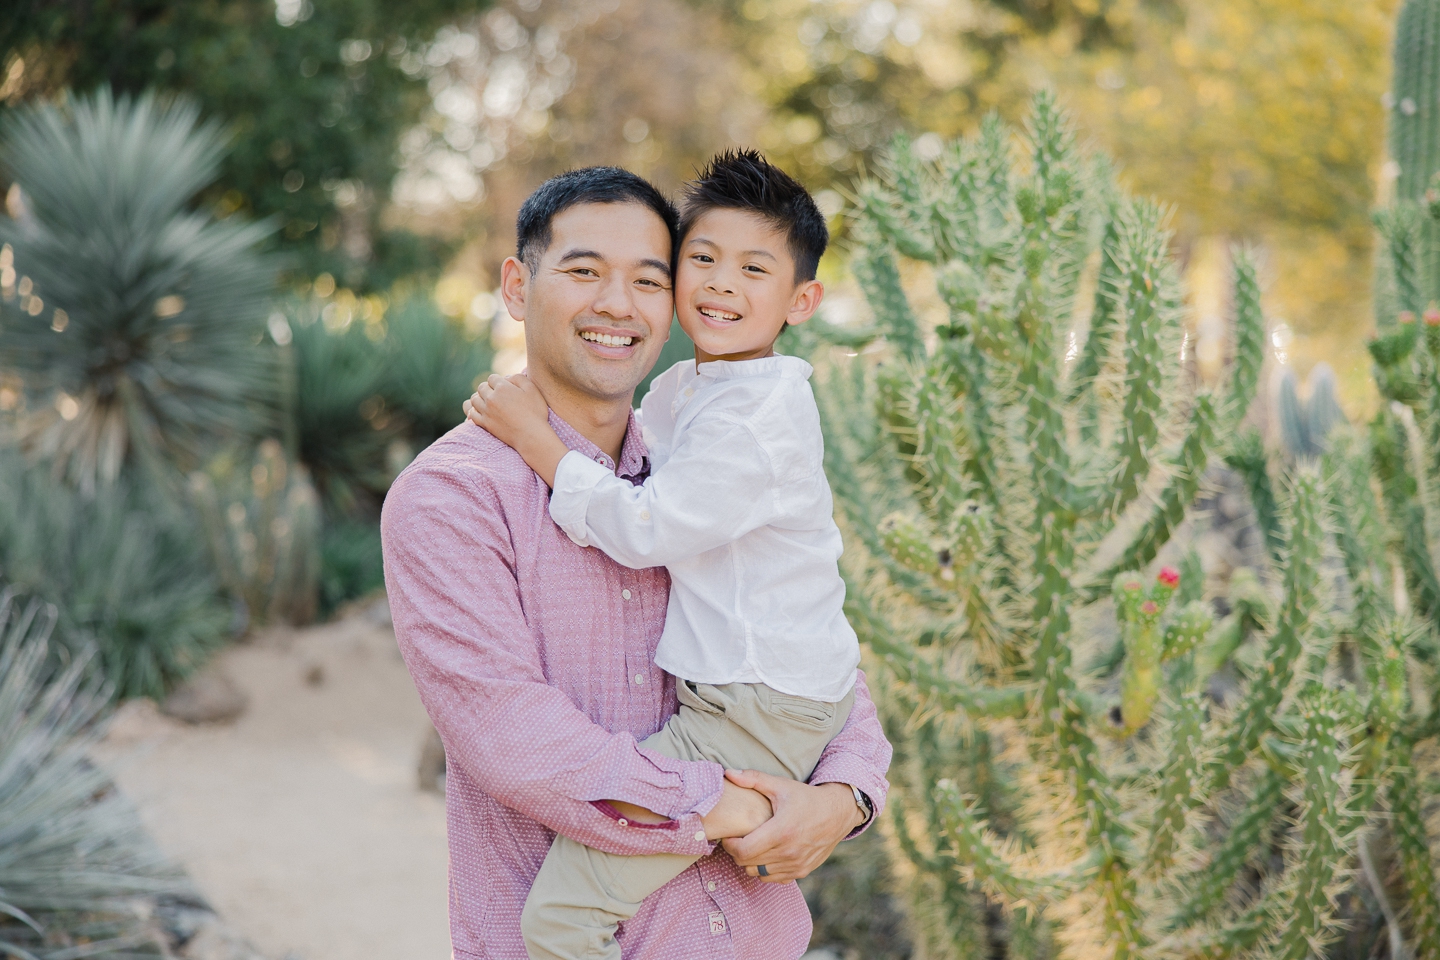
503,203 -> 674,402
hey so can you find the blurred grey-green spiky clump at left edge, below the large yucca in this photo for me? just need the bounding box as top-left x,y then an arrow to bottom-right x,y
0,449 -> 235,698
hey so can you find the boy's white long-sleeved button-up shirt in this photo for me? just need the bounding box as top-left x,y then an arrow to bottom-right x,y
550,357 -> 860,702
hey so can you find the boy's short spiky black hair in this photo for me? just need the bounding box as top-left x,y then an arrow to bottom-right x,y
677,150 -> 829,284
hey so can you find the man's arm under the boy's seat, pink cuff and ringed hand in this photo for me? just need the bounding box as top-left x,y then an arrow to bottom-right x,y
724,672 -> 893,884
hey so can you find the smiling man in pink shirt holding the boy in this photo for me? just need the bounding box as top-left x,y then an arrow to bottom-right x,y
383,167 -> 890,960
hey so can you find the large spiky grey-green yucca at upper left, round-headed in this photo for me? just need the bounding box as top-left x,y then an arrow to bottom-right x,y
0,89 -> 275,489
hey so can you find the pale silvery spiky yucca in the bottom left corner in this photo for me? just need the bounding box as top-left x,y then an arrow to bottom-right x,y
0,586 -> 196,960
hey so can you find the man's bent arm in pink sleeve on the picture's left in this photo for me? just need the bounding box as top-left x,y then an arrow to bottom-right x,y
382,468 -> 721,855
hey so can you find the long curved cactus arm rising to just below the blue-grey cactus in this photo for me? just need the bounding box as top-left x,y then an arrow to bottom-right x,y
1210,469 -> 1325,790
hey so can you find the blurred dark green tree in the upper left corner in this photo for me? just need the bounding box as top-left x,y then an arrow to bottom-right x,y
0,0 -> 487,288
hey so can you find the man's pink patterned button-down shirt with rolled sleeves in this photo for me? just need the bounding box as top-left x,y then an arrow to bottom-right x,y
382,415 -> 890,960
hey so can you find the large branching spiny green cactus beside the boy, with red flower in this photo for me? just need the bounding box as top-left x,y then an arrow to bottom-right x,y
818,94 -> 1436,960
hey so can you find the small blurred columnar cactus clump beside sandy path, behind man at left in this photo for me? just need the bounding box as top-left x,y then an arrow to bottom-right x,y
190,440 -> 320,625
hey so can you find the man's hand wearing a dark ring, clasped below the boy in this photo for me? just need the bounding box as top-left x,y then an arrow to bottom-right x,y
724,770 -> 865,884
